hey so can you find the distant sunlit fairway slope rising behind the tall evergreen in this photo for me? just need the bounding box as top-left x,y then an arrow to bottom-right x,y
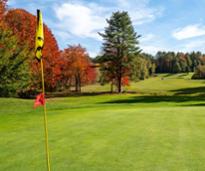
82,73 -> 205,95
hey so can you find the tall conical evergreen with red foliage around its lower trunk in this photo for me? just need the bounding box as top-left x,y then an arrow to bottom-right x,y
100,11 -> 139,93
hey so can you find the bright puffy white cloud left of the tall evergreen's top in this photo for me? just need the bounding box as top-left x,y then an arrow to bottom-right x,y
55,3 -> 105,40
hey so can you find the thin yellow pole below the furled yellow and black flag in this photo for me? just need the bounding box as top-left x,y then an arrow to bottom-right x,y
41,59 -> 51,171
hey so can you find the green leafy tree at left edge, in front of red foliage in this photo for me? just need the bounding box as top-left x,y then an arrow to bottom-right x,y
0,27 -> 29,96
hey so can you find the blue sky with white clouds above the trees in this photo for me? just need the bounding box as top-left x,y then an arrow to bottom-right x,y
8,0 -> 205,57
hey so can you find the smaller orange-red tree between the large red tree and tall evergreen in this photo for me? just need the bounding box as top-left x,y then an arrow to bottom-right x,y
61,45 -> 96,92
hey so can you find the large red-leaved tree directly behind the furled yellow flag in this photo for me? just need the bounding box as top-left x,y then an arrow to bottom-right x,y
5,9 -> 62,91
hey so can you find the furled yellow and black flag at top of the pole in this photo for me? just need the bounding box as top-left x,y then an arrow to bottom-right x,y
35,10 -> 44,61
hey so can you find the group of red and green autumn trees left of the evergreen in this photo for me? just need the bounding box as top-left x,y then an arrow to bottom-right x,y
0,0 -> 96,97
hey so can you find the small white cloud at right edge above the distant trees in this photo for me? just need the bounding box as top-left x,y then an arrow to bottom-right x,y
172,24 -> 205,40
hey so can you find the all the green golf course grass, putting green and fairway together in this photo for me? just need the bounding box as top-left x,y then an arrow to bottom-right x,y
0,74 -> 205,171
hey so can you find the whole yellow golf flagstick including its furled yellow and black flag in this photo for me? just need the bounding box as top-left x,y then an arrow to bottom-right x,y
35,10 -> 51,171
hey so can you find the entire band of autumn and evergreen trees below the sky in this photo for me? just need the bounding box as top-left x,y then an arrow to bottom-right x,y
0,0 -> 205,97
